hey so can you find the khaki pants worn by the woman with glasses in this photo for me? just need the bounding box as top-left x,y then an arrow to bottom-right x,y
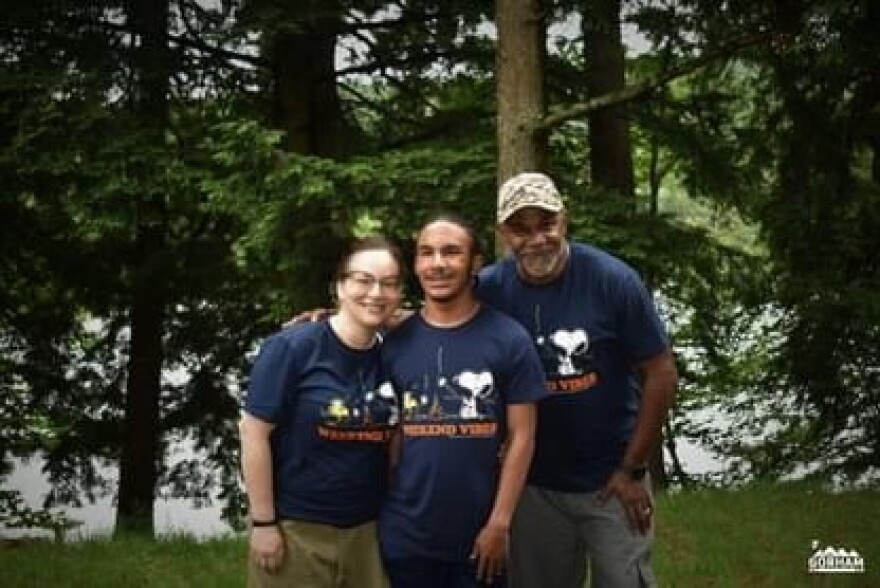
248,521 -> 388,588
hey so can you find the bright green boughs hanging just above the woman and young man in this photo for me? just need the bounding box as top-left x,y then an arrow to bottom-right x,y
204,115 -> 494,308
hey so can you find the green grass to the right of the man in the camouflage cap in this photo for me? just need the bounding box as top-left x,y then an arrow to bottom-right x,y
654,483 -> 880,588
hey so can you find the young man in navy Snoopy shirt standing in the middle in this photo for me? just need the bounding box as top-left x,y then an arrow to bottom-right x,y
379,215 -> 546,588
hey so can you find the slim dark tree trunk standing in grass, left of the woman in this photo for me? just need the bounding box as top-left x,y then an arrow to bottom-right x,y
116,0 -> 169,536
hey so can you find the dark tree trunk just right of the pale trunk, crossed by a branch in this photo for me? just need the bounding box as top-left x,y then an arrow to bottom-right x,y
582,0 -> 635,199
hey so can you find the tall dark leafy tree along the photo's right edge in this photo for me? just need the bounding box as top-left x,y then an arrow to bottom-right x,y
763,2 -> 880,474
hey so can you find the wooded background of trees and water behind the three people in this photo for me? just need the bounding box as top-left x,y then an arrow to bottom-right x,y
0,0 -> 880,535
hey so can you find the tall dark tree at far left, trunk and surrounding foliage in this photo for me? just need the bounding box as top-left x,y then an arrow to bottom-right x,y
0,2 -> 264,534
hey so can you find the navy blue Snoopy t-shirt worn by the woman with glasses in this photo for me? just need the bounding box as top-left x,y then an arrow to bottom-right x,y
244,322 -> 399,527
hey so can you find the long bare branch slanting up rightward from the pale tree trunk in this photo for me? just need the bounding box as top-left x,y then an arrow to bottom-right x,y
532,33 -> 775,132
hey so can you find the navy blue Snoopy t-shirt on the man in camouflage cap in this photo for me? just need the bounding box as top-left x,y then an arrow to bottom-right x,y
477,243 -> 669,492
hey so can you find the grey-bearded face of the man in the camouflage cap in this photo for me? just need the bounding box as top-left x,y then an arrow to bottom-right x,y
499,206 -> 568,284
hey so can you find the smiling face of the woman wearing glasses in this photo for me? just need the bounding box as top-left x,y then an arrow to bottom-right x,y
336,249 -> 403,329
